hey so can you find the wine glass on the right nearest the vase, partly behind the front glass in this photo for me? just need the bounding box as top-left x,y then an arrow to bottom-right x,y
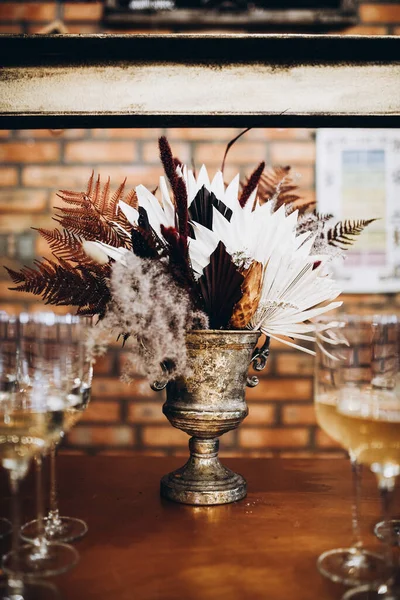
314,316 -> 385,586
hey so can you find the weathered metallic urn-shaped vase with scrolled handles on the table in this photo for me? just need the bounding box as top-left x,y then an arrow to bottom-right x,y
155,330 -> 268,505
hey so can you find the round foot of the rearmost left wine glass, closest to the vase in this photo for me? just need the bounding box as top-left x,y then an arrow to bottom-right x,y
21,517 -> 88,543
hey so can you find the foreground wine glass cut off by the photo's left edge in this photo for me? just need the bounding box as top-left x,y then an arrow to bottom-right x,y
0,312 -> 59,600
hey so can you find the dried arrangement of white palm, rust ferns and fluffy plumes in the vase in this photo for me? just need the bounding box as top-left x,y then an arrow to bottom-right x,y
8,136 -> 374,379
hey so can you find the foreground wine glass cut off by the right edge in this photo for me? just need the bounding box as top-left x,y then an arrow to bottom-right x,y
337,315 -> 400,600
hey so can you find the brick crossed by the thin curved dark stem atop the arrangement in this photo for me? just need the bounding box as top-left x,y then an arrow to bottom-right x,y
194,141 -> 267,165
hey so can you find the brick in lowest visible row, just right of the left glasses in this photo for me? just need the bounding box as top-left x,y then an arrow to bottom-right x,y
67,425 -> 135,446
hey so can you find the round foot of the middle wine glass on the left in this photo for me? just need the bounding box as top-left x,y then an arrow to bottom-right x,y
2,543 -> 79,578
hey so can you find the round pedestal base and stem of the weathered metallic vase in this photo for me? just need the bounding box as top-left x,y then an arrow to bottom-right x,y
161,438 -> 247,506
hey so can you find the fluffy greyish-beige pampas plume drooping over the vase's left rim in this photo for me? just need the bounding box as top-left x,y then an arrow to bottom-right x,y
90,253 -> 208,383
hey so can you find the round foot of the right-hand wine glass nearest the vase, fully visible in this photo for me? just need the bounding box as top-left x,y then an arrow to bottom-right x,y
317,548 -> 387,586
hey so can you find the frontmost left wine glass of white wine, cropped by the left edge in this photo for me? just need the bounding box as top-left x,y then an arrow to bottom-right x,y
0,313 -> 77,600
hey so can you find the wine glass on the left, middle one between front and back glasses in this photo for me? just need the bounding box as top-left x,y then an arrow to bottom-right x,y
3,313 -> 79,576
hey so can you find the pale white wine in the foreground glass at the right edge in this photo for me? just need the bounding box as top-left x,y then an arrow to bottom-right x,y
338,387 -> 400,470
